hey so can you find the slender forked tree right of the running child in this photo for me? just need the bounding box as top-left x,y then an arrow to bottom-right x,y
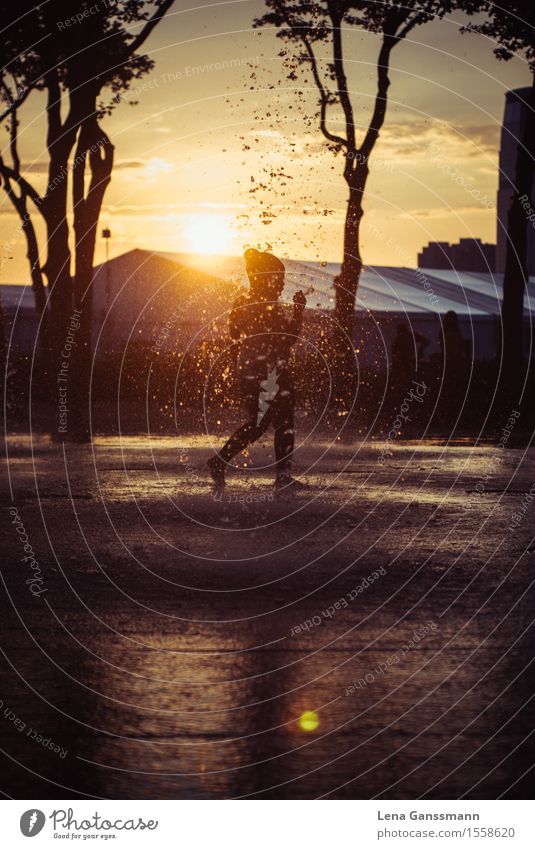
255,0 -> 482,406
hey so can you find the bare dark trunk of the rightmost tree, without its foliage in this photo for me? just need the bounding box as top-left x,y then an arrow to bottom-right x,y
502,76 -> 535,402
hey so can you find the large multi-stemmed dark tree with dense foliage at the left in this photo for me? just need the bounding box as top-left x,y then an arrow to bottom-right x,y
0,0 -> 173,439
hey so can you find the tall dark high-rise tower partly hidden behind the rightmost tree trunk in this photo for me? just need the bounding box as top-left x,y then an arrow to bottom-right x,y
496,87 -> 535,275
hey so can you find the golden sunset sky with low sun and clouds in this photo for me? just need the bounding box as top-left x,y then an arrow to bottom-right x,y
0,0 -> 530,283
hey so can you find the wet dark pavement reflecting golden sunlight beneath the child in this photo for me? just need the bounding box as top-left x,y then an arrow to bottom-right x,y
0,437 -> 535,798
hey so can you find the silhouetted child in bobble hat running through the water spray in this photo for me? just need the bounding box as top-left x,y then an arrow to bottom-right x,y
208,249 -> 306,489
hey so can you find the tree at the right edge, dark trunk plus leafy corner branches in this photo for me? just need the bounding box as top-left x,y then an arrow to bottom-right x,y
468,0 -> 535,396
